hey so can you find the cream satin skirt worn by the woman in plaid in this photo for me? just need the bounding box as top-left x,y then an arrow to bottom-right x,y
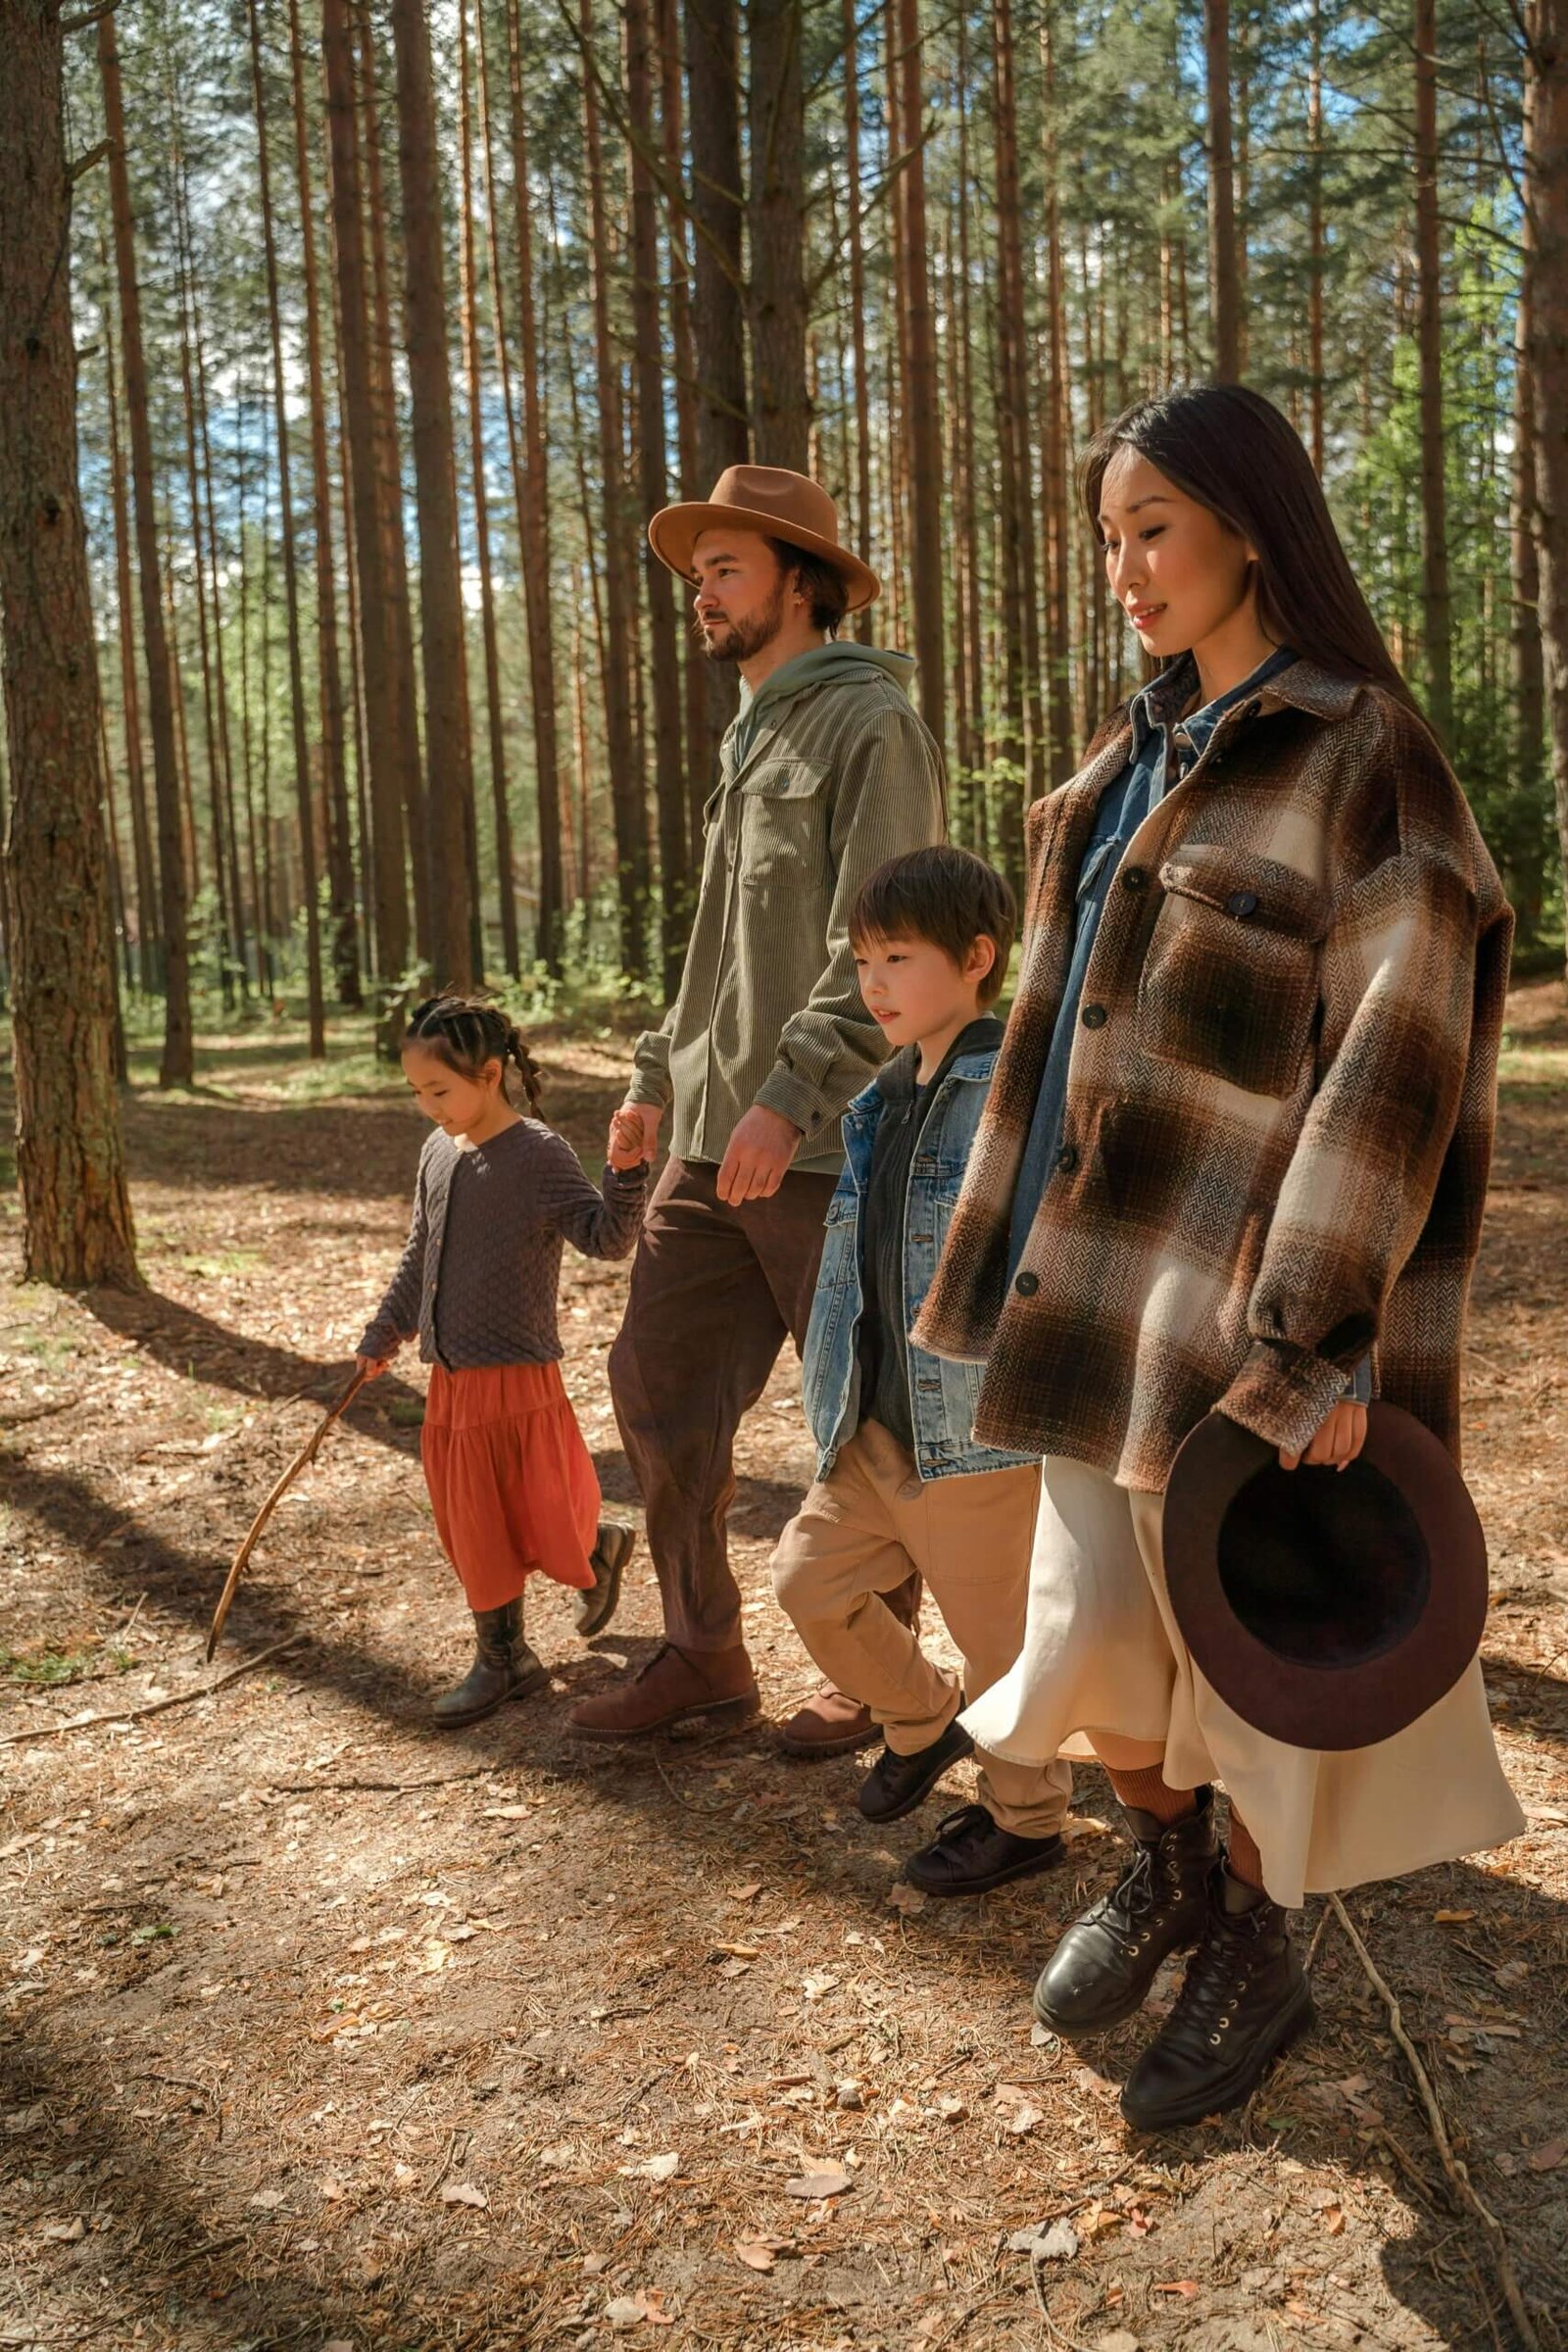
964,1456 -> 1523,1905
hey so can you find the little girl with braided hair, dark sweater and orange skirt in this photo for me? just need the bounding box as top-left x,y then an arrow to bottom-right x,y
358,995 -> 649,1729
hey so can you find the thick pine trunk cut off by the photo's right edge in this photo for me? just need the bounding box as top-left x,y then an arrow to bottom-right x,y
1526,0 -> 1568,973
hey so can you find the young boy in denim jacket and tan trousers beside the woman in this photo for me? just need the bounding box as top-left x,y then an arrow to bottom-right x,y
773,847 -> 1072,1895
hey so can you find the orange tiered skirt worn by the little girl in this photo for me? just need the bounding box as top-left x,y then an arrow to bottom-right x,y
420,1364 -> 600,1609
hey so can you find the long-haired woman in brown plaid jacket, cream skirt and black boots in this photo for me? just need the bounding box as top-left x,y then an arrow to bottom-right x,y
914,386 -> 1521,2131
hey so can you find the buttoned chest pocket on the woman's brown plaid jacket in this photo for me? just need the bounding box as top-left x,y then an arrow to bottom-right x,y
1138,842 -> 1328,1096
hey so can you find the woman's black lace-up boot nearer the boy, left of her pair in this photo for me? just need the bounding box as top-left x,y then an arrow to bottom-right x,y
1034,1788 -> 1220,2034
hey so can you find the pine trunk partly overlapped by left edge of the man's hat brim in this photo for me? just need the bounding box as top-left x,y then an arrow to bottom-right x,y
625,0 -> 691,1000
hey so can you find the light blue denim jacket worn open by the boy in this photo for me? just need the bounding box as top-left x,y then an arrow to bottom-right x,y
804,1052 -> 1037,1480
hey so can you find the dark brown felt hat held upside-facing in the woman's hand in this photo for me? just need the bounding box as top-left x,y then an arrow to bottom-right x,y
1163,1404 -> 1486,1750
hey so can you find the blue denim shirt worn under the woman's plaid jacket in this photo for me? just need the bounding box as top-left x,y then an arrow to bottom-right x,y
1006,647 -> 1296,1282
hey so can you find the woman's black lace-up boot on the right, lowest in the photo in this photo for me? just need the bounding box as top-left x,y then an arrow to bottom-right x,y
1121,1865 -> 1312,2131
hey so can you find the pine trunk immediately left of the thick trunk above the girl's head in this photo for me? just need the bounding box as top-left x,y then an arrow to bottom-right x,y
322,0 -> 409,1011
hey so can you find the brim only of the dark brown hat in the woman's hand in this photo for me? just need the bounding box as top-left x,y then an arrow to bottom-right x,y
1163,1404 -> 1488,1752
